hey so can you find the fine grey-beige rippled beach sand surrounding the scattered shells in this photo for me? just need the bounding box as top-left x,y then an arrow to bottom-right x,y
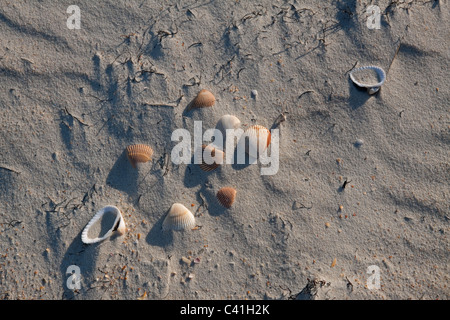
0,0 -> 450,300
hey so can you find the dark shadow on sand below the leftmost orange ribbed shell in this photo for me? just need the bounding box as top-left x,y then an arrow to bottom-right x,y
106,150 -> 139,195
